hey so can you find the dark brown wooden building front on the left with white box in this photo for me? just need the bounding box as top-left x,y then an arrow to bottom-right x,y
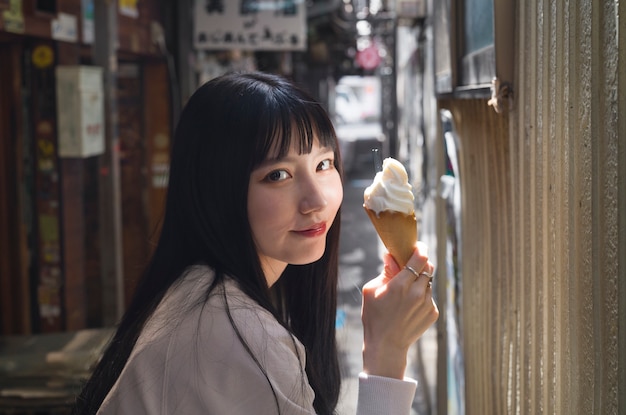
0,0 -> 171,334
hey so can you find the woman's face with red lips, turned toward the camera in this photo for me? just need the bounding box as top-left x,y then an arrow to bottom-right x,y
248,136 -> 343,286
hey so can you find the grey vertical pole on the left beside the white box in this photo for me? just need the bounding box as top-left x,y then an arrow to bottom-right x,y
93,0 -> 124,326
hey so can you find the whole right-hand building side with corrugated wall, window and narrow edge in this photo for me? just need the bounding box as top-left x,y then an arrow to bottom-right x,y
416,0 -> 626,414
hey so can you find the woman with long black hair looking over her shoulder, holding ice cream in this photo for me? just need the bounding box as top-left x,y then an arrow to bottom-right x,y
75,73 -> 437,415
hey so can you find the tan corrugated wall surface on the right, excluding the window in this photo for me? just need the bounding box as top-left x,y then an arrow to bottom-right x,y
439,0 -> 626,414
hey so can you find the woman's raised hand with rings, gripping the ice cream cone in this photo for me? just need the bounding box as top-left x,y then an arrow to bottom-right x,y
361,242 -> 439,379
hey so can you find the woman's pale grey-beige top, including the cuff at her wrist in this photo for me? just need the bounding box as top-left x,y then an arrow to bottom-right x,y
98,266 -> 416,415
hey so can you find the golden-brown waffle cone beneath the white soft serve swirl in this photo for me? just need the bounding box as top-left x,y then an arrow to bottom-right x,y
364,207 -> 417,267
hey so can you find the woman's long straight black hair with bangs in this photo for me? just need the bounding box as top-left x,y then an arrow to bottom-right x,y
74,72 -> 341,415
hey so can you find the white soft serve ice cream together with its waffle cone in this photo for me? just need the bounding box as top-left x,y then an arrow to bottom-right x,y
363,158 -> 417,267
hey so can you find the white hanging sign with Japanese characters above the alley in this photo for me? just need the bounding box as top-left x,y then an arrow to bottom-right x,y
194,0 -> 306,51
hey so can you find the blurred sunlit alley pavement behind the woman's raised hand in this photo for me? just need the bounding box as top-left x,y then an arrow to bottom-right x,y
337,154 -> 437,415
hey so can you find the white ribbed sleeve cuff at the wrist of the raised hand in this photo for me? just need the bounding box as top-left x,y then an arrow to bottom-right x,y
356,372 -> 417,415
